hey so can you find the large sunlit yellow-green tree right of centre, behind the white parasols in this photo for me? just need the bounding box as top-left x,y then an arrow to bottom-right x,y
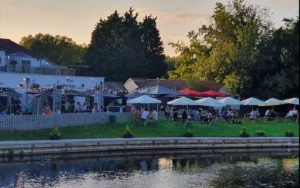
170,0 -> 270,95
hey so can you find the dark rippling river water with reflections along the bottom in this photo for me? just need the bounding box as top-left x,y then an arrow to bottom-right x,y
0,149 -> 299,188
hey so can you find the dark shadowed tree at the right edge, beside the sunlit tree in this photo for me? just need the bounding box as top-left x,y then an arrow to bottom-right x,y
258,17 -> 299,98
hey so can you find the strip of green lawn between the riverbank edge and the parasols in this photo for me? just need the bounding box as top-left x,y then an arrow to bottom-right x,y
0,121 -> 299,141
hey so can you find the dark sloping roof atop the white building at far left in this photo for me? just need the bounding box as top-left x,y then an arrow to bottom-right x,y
0,38 -> 38,57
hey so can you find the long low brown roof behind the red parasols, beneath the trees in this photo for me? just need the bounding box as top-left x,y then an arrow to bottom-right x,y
126,78 -> 224,91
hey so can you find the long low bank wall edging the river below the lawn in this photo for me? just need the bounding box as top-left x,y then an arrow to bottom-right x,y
0,137 -> 299,156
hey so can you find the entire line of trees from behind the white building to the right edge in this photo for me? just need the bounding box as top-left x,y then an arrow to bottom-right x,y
20,0 -> 299,98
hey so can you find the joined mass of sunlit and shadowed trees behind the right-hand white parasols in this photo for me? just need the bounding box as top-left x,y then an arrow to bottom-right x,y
169,0 -> 299,97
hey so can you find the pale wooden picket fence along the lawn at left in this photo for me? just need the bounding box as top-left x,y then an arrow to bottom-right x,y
0,112 -> 131,131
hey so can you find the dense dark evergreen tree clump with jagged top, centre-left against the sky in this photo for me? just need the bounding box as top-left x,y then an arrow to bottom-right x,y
85,8 -> 166,81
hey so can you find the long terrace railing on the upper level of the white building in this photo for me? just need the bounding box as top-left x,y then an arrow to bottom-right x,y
0,65 -> 76,76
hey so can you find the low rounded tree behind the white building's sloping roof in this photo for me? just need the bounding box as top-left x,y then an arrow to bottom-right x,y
20,33 -> 86,65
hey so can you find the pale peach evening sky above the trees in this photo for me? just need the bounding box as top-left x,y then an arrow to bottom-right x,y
0,0 -> 299,56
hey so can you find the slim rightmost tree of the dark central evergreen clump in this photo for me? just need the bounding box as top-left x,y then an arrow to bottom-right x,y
140,16 -> 167,78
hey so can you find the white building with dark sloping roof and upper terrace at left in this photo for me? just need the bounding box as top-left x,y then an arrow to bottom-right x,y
0,38 -> 104,113
